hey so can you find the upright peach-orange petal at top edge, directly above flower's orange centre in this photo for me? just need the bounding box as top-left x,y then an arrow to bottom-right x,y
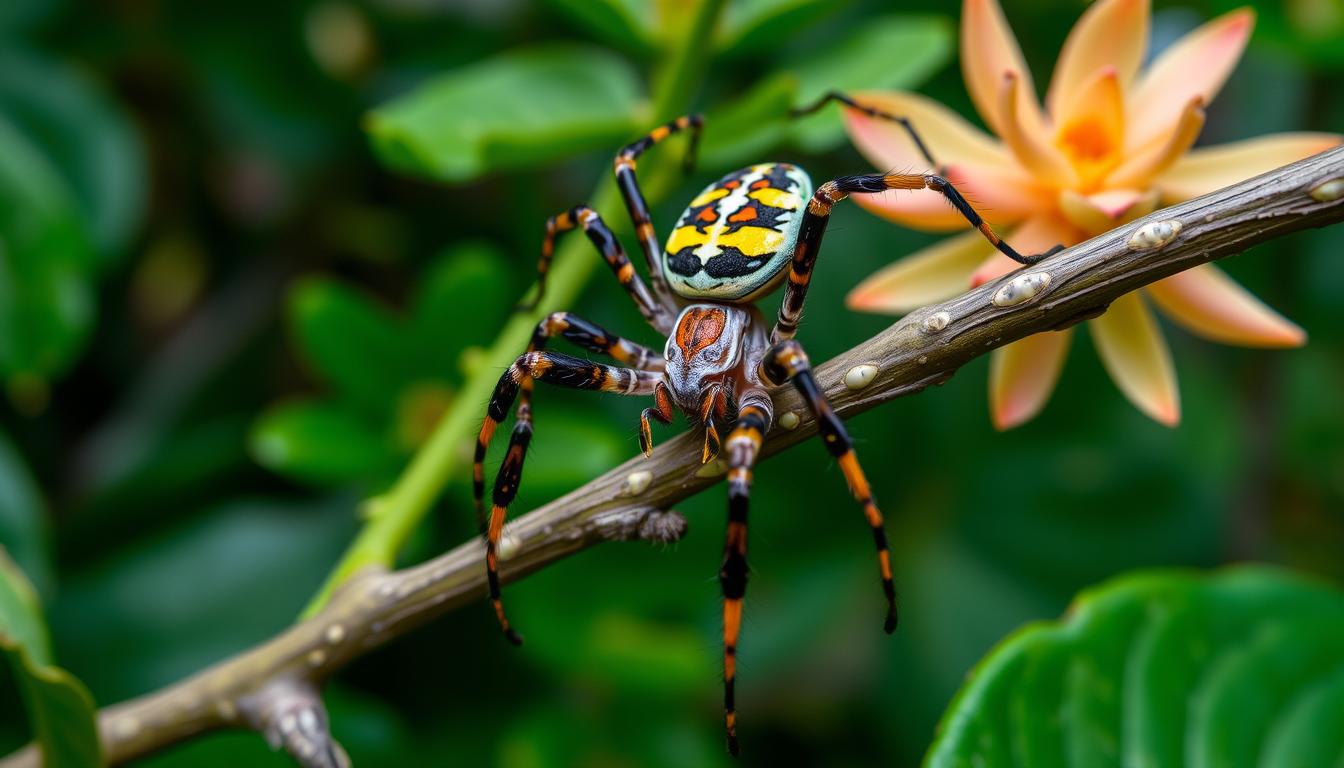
1046,0 -> 1149,120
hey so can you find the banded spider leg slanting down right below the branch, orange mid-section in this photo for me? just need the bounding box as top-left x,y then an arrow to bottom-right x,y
761,340 -> 896,635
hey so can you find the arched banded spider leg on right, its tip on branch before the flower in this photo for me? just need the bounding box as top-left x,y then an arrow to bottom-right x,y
770,174 -> 1063,343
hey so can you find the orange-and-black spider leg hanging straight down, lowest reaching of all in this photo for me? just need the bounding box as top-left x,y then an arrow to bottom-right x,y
719,393 -> 770,755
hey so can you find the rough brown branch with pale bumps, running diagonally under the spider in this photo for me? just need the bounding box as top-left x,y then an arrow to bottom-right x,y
0,148 -> 1344,768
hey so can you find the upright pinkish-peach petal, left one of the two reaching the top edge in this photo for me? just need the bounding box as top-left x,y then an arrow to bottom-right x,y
961,0 -> 1046,136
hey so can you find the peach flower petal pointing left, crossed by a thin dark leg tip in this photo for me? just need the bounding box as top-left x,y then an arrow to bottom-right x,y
844,91 -> 1012,171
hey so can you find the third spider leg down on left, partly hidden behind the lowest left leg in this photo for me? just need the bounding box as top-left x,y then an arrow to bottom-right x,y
472,312 -> 672,535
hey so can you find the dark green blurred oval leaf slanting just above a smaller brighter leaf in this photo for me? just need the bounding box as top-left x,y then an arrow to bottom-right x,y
289,277 -> 419,416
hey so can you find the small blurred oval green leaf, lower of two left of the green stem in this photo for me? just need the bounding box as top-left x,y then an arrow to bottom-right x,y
250,402 -> 391,486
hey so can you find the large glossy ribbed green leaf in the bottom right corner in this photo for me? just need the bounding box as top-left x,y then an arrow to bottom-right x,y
925,568 -> 1344,768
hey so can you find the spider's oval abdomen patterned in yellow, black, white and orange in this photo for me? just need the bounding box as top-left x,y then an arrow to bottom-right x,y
663,163 -> 812,301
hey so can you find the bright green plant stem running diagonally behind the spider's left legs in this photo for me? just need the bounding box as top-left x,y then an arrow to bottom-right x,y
302,0 -> 723,617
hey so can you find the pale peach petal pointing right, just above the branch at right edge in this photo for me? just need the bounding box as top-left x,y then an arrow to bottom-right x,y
1156,132 -> 1344,203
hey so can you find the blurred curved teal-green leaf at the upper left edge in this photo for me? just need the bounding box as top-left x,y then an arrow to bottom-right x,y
0,47 -> 145,264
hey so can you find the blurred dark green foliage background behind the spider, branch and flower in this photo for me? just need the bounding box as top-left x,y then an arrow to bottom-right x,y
0,0 -> 1344,767
